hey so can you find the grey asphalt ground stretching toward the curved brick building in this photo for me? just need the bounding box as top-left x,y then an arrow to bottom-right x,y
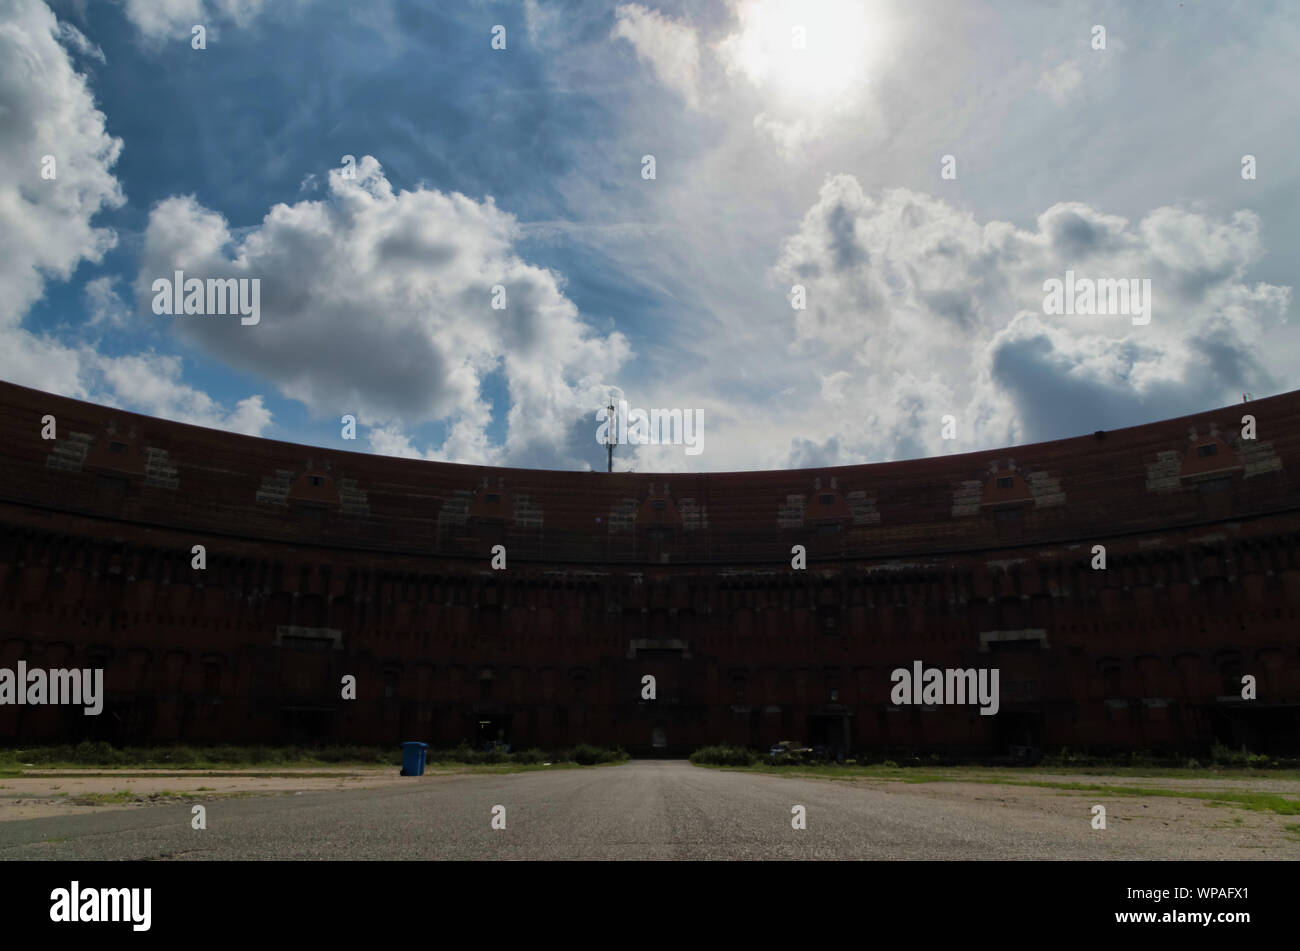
0,761 -> 1300,861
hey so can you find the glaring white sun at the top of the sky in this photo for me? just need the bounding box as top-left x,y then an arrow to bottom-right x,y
718,0 -> 883,108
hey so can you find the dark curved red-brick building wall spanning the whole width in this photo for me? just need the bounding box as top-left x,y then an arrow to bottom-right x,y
0,385 -> 1300,752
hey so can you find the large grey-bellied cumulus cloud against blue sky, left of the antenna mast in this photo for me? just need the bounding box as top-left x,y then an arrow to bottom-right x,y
137,156 -> 629,464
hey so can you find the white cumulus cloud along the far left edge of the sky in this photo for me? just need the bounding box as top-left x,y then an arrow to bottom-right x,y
0,0 -> 270,434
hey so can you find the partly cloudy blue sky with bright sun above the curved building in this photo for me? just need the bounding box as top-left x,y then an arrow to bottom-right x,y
0,0 -> 1300,472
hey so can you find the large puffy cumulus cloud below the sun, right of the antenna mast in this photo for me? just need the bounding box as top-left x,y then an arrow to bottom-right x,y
772,175 -> 1290,465
